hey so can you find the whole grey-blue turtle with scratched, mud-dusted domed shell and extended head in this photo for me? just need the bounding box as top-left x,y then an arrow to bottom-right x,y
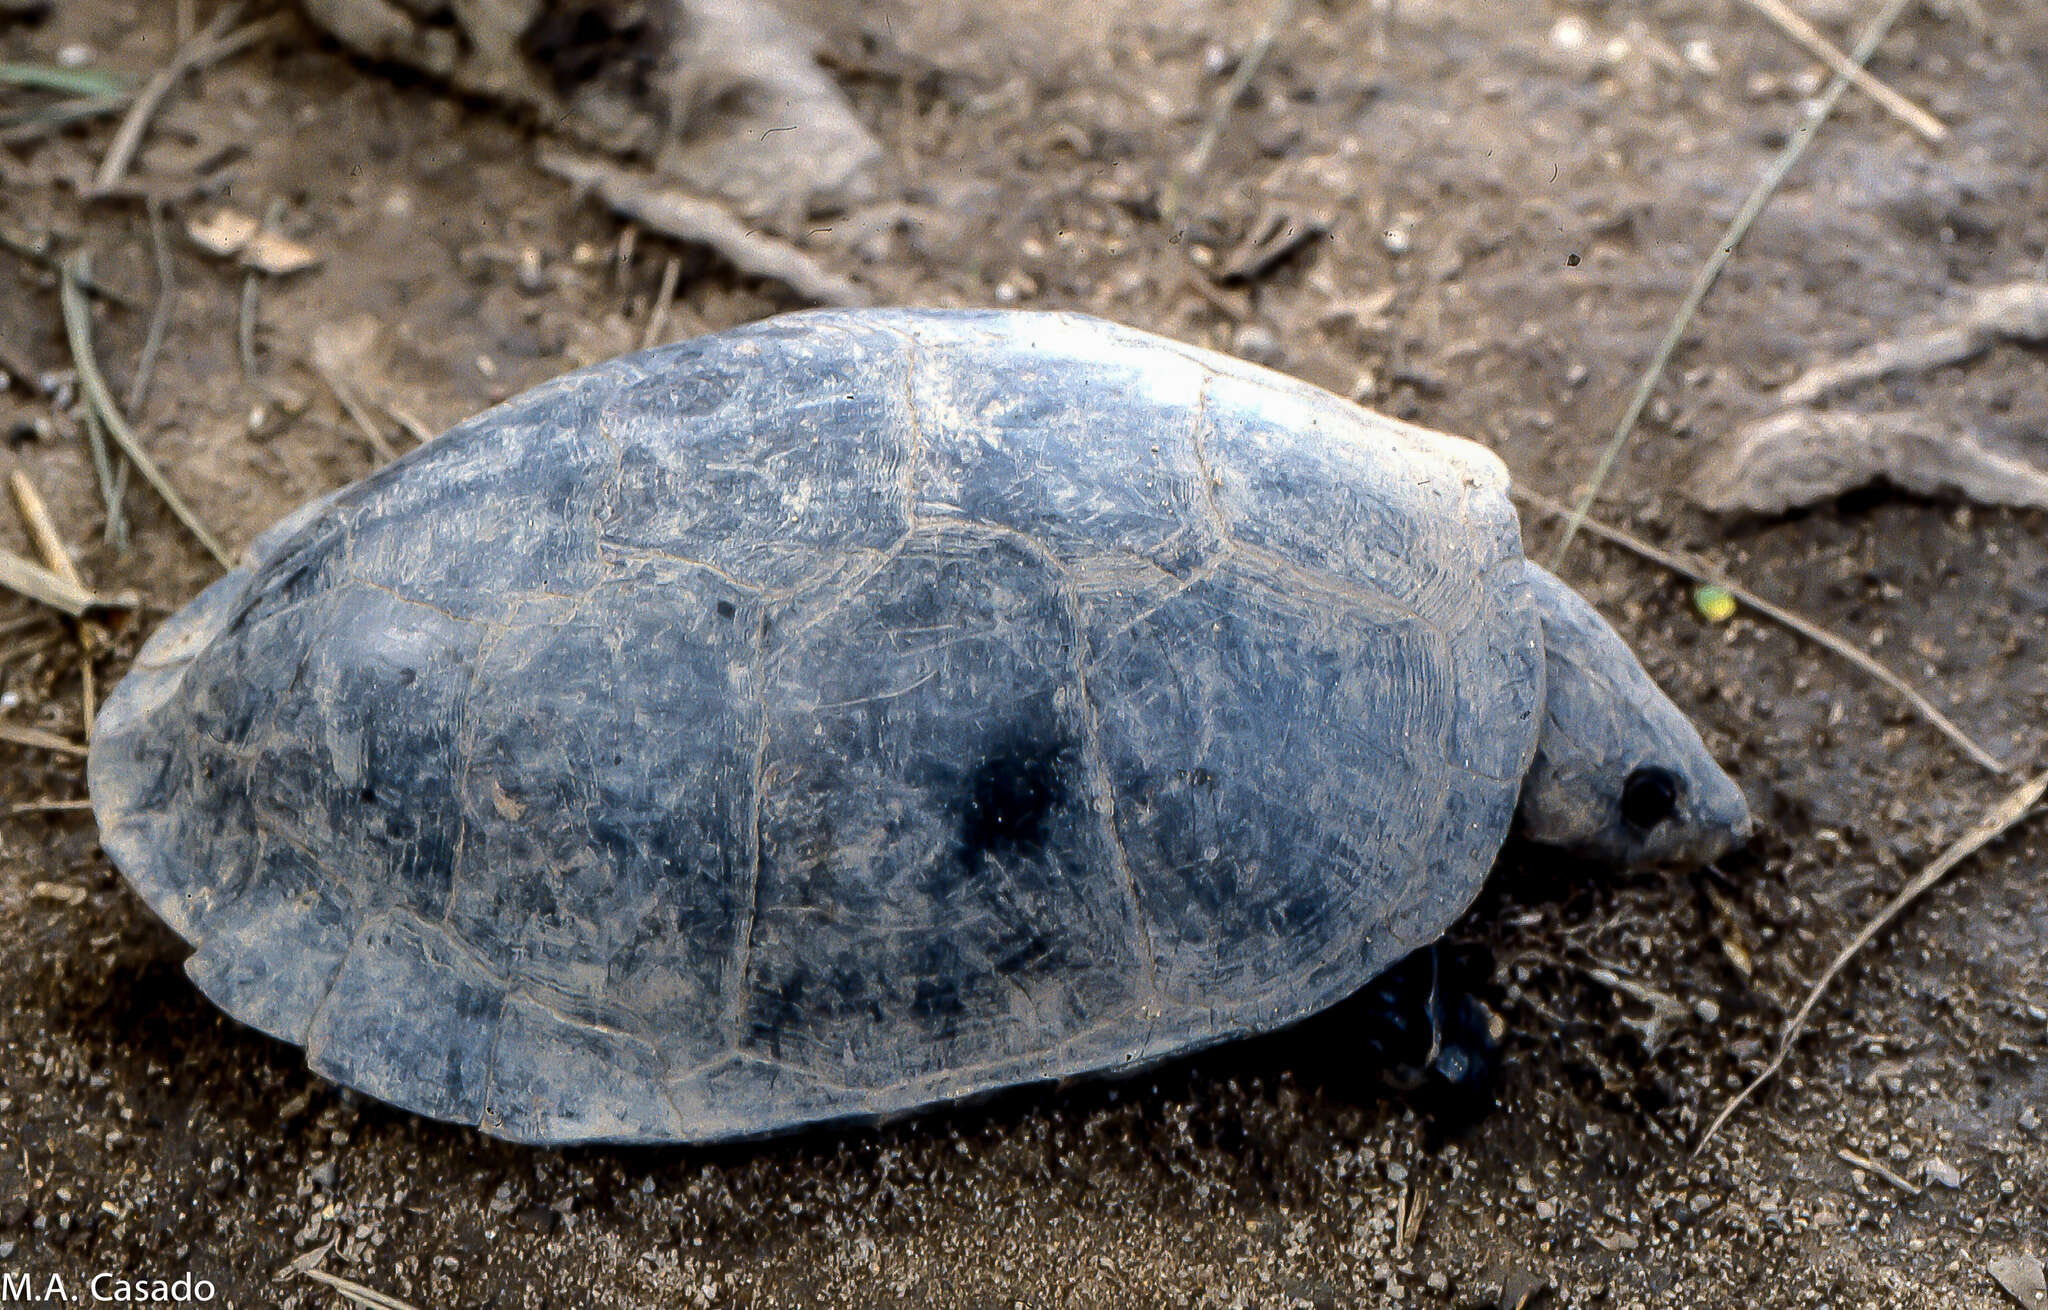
88,309 -> 1751,1144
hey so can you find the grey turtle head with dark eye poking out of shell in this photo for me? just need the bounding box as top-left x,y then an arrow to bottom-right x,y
1518,565 -> 1751,866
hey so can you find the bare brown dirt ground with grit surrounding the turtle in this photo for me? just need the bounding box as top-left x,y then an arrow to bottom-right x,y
0,0 -> 2048,1310
